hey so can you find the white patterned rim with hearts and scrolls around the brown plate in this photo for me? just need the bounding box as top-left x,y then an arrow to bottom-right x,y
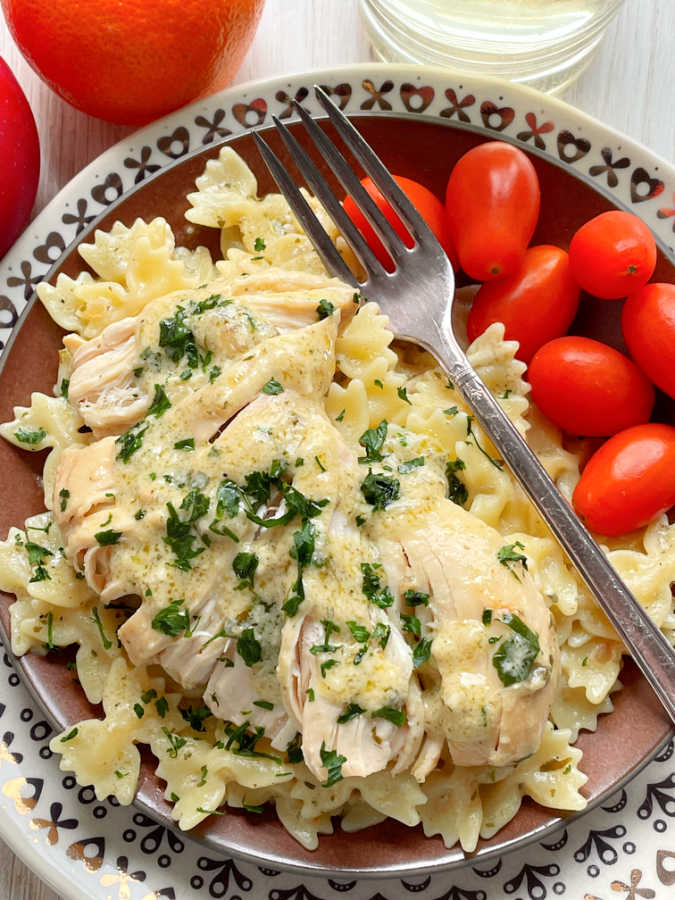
0,65 -> 675,900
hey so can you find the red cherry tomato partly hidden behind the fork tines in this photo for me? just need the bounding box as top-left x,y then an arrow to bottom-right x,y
342,175 -> 457,272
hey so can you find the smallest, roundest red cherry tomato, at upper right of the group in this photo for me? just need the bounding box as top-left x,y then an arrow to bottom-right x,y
570,210 -> 656,300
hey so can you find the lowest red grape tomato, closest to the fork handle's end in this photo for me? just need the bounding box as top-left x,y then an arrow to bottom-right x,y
572,422 -> 675,537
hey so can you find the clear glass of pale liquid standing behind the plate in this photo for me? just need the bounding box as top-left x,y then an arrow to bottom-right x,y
361,0 -> 623,93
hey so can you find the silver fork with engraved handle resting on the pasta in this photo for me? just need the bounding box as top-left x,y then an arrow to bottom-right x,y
253,86 -> 675,722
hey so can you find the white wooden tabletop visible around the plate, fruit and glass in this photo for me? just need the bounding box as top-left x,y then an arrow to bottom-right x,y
0,0 -> 675,900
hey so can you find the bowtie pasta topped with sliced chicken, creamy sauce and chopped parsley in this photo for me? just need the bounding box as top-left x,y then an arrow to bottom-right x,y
0,148 -> 675,851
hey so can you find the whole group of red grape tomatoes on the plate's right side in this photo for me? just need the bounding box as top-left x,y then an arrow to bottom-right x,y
344,141 -> 675,536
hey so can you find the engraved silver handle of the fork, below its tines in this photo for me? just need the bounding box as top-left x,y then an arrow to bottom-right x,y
439,338 -> 675,723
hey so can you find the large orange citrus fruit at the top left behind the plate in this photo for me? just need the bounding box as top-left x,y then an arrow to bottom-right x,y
2,0 -> 264,125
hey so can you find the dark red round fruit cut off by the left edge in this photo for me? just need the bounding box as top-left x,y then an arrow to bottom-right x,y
0,58 -> 40,257
